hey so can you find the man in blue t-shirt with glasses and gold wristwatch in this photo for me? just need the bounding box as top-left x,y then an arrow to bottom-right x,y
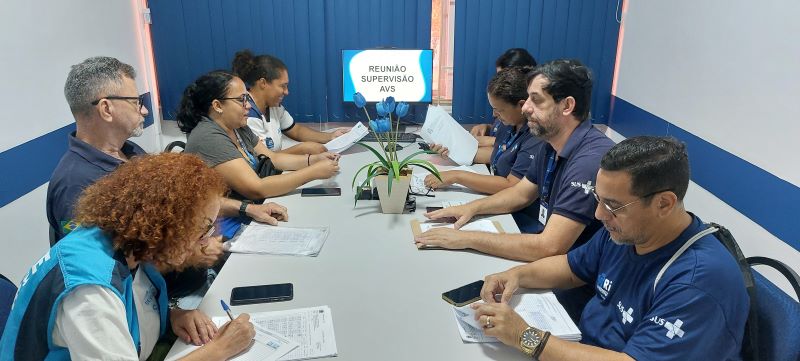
474,137 -> 750,361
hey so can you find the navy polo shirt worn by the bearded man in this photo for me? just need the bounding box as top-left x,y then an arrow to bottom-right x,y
525,120 -> 614,248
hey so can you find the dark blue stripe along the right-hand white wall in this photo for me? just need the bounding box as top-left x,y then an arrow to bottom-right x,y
609,97 -> 800,251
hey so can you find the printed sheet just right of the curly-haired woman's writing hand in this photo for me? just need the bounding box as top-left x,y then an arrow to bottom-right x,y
238,306 -> 339,361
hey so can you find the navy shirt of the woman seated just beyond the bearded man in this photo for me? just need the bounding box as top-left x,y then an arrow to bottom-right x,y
489,123 -> 544,233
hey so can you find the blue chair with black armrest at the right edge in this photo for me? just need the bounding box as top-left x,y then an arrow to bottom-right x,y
747,257 -> 800,361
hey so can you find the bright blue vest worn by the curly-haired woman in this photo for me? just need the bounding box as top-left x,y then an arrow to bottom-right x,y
0,227 -> 169,361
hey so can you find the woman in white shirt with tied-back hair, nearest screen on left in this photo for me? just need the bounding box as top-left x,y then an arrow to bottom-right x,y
228,50 -> 348,154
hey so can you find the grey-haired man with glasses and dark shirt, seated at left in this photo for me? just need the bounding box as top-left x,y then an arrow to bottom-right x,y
47,57 -> 286,242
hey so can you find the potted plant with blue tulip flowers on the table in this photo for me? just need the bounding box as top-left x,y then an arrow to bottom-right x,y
352,93 -> 441,213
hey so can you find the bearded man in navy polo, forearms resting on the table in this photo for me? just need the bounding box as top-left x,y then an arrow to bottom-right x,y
416,60 -> 614,261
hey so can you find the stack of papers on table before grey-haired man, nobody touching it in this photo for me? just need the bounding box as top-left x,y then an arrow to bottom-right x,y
225,222 -> 329,257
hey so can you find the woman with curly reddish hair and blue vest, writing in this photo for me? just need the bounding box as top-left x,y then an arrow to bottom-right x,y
0,153 -> 255,360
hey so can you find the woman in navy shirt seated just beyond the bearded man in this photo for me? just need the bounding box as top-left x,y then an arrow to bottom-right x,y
425,67 -> 542,233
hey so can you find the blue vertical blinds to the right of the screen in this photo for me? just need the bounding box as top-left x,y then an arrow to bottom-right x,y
453,0 -> 619,123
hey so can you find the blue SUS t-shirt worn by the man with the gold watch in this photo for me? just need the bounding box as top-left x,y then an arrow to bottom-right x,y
567,215 -> 750,360
